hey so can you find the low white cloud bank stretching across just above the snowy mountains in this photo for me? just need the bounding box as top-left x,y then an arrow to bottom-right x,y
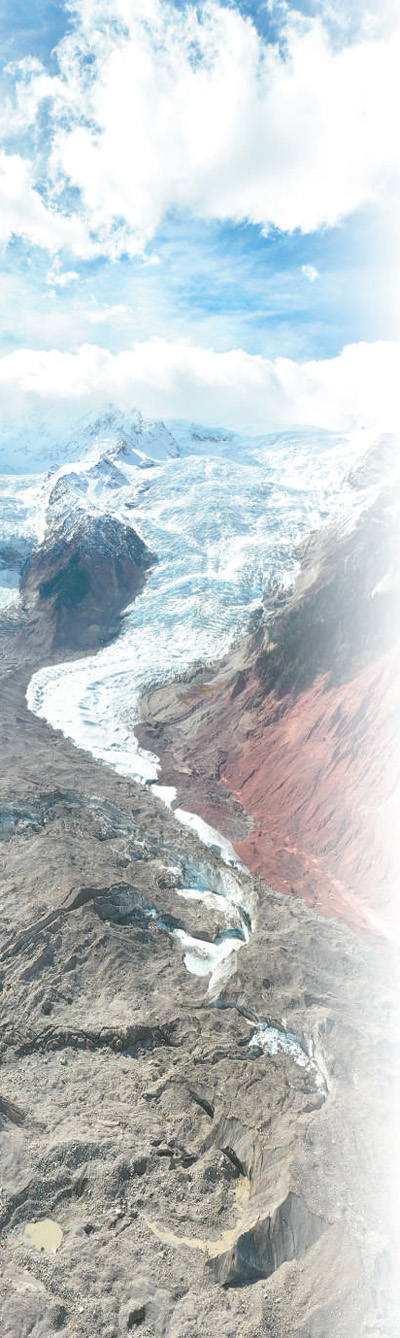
0,339 -> 400,432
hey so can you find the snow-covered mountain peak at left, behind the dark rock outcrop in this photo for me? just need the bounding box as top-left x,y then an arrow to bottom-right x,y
0,405 -> 179,607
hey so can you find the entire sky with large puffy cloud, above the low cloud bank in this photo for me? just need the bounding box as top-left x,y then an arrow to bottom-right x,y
0,0 -> 399,428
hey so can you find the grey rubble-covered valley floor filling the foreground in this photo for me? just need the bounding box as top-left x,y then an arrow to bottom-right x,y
0,610 -> 399,1338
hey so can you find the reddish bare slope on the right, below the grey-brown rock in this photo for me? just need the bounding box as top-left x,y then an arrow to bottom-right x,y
221,657 -> 400,935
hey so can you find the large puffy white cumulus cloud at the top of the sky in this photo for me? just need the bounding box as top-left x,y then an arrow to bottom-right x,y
3,0 -> 400,256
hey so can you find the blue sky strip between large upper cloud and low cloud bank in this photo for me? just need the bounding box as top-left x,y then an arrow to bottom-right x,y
0,210 -> 396,359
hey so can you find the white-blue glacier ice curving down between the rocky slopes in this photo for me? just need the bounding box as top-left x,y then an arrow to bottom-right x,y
0,423 -> 360,780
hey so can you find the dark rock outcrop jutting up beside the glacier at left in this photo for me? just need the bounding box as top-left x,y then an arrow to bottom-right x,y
21,479 -> 157,650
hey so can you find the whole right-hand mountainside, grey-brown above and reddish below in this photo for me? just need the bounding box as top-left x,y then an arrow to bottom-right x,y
139,465 -> 400,939
